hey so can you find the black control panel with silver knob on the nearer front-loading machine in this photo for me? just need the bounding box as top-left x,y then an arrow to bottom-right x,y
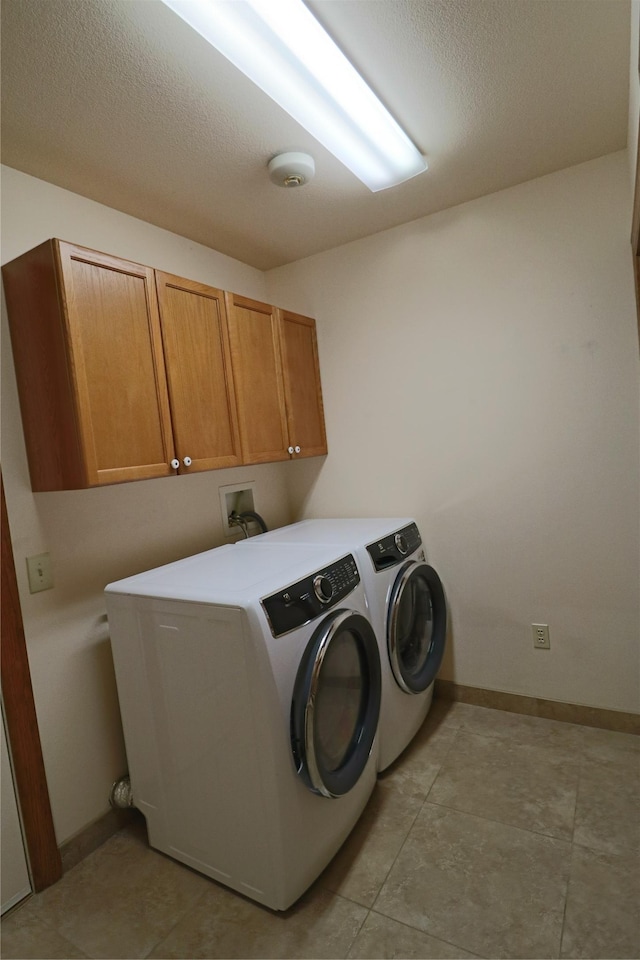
260,553 -> 360,637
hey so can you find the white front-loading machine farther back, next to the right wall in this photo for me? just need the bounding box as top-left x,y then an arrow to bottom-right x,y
244,518 -> 447,770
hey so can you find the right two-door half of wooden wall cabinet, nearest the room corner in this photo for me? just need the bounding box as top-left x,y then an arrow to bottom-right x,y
226,293 -> 327,463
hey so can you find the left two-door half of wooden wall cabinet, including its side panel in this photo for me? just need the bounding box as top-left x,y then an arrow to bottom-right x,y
3,240 -> 240,491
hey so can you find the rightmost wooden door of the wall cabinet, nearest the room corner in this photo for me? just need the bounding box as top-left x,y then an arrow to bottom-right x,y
279,310 -> 327,457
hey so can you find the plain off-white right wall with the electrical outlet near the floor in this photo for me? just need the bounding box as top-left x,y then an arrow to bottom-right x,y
267,152 -> 640,710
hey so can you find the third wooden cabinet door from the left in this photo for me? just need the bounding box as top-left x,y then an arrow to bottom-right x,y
225,293 -> 289,463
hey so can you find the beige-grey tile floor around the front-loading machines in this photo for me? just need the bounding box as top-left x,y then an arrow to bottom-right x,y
2,700 -> 640,960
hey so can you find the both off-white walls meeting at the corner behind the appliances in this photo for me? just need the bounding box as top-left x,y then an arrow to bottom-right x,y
2,153 -> 639,842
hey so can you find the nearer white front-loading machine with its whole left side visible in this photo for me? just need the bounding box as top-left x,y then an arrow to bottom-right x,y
105,543 -> 381,910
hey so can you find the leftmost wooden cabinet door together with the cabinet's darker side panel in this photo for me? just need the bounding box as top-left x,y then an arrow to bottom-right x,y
3,240 -> 174,491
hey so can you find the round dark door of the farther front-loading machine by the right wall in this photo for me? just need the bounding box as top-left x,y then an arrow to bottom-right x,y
387,560 -> 447,693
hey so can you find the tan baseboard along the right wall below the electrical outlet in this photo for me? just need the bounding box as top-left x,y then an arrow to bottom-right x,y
434,679 -> 640,734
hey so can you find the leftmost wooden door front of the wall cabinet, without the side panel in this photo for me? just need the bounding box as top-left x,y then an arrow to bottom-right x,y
59,243 -> 173,483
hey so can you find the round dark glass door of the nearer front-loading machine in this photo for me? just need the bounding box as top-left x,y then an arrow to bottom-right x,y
291,610 -> 381,797
